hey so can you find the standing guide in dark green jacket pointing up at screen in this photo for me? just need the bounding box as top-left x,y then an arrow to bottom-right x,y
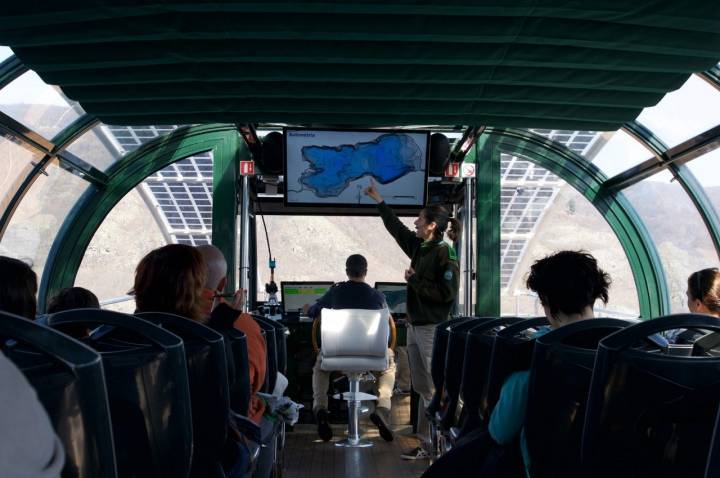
365,179 -> 460,460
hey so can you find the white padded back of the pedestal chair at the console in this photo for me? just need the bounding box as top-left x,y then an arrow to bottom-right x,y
320,309 -> 390,372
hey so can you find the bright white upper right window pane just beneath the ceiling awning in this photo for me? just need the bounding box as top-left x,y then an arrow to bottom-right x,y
638,75 -> 720,147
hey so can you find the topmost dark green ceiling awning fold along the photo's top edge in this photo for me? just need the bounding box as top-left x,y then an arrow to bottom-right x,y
0,0 -> 717,32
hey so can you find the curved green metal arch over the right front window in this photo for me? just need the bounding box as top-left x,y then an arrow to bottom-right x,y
478,128 -> 670,319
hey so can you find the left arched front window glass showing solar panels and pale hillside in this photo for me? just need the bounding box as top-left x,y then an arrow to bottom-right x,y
76,151 -> 213,312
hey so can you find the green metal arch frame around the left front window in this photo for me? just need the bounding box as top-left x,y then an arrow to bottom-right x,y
38,124 -> 244,311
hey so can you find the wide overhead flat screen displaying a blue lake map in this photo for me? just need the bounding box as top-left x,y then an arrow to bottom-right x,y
284,128 -> 430,207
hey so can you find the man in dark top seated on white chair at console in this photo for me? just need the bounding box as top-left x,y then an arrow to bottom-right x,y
305,254 -> 395,441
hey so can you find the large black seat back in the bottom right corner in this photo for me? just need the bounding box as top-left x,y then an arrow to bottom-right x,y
582,314 -> 720,477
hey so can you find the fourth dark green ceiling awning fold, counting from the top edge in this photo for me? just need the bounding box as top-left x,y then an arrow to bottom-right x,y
35,63 -> 687,95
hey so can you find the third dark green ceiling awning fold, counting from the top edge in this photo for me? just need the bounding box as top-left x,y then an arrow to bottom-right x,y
15,40 -> 720,74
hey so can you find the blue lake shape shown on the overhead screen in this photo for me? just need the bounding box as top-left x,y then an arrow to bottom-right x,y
300,133 -> 423,197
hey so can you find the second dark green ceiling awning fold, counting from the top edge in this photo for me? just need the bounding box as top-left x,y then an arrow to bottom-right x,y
2,12 -> 720,57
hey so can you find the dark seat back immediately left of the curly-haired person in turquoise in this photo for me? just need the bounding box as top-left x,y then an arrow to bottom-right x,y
480,317 -> 548,419
